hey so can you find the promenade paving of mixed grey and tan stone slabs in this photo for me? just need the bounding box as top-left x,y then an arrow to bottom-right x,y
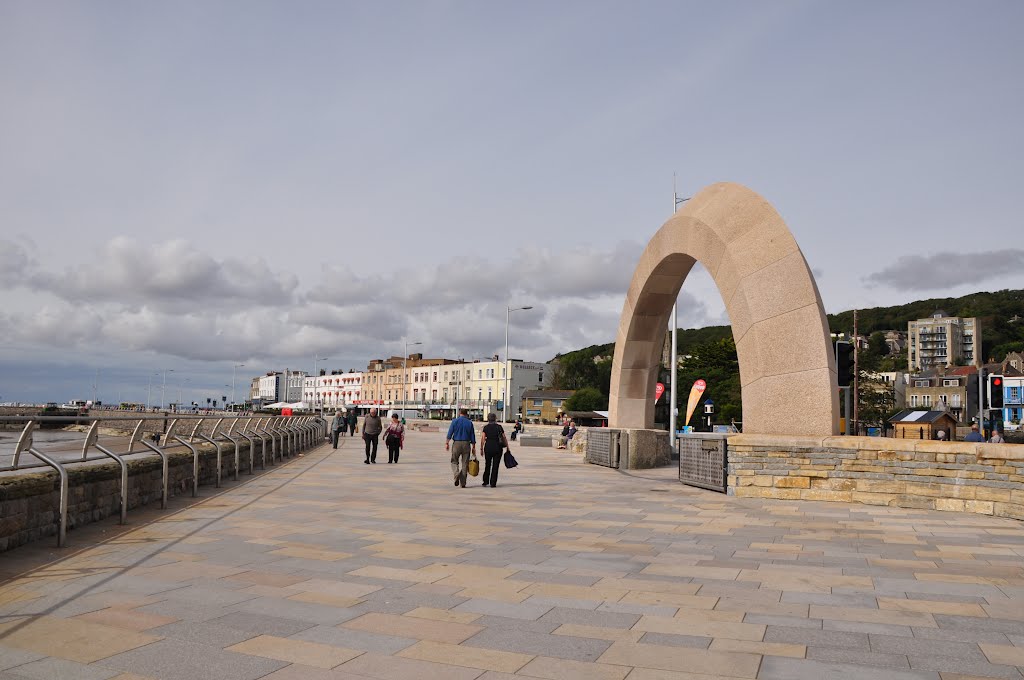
0,433 -> 1024,680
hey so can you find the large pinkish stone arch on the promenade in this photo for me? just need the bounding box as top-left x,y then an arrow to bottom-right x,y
609,182 -> 839,436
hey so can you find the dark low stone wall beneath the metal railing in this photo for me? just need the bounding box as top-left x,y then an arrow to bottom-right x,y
0,441 -> 270,551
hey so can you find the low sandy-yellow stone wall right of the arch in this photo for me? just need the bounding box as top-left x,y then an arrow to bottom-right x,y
728,434 -> 1024,519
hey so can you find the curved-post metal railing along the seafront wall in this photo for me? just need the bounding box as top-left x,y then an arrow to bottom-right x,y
0,414 -> 327,548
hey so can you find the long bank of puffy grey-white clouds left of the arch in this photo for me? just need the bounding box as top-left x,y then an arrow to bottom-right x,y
0,237 -> 655,368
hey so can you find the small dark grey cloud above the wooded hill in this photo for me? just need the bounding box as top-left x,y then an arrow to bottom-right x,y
864,249 -> 1024,291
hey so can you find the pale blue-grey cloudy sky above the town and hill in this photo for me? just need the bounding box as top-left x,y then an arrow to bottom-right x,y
0,0 -> 1024,403
